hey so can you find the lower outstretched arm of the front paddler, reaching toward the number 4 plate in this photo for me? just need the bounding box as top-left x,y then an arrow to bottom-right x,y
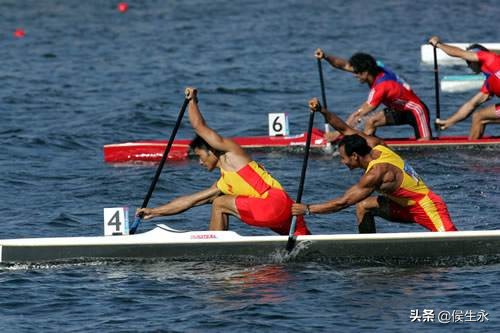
136,183 -> 221,220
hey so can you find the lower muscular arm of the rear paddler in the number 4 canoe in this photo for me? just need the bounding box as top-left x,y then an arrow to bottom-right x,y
292,168 -> 383,215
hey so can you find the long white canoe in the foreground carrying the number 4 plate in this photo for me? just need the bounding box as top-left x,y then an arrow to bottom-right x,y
0,225 -> 500,263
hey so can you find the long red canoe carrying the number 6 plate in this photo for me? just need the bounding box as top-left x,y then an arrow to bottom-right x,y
104,129 -> 500,163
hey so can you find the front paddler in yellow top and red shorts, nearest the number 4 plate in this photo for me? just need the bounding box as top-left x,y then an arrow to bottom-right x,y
137,88 -> 310,235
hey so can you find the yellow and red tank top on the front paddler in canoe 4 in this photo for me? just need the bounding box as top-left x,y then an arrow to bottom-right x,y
217,161 -> 283,198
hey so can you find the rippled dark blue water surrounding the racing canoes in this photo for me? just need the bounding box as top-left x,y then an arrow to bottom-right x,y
0,0 -> 500,332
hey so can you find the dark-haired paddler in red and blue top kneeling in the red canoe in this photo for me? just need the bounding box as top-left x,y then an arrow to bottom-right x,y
315,49 -> 432,140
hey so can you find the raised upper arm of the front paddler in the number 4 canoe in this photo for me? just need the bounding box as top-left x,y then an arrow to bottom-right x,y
186,88 -> 244,154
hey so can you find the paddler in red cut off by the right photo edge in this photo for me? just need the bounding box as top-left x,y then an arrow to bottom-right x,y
429,36 -> 500,140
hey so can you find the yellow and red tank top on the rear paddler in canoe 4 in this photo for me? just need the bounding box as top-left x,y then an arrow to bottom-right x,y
366,145 -> 430,206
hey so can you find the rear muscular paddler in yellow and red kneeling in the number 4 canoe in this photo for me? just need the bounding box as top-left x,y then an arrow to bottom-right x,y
292,98 -> 457,233
